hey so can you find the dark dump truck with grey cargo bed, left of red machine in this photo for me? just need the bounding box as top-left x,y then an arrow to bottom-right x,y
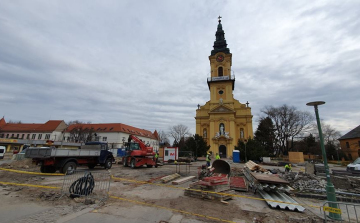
25,142 -> 115,174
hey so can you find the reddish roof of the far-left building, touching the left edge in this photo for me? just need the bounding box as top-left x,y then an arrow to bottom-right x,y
0,120 -> 63,132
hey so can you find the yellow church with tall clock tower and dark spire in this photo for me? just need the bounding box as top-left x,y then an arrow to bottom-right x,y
195,16 -> 254,158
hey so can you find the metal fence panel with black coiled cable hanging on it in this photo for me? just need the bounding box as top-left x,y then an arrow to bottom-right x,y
61,170 -> 111,200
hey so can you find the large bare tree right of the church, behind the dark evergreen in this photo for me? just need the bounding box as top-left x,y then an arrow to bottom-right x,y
261,105 -> 314,154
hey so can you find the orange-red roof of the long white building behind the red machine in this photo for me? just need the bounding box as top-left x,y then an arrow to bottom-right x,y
66,123 -> 156,139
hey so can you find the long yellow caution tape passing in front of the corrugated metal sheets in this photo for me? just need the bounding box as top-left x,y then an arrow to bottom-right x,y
111,175 -> 321,208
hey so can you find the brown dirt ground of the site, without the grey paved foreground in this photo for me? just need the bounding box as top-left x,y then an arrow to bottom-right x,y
0,160 -> 322,223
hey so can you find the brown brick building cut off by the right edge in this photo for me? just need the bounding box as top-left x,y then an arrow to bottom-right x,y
339,125 -> 360,160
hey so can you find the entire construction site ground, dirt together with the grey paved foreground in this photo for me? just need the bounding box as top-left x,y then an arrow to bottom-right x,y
0,160 -> 340,223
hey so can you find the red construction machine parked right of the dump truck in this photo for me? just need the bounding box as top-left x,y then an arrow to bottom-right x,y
122,135 -> 157,169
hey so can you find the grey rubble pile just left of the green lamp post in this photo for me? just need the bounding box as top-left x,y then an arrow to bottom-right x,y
280,172 -> 326,191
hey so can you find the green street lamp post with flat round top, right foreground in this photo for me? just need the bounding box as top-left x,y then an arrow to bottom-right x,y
306,101 -> 341,220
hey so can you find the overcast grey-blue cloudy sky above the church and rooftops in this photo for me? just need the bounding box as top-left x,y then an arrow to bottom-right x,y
0,0 -> 360,137
